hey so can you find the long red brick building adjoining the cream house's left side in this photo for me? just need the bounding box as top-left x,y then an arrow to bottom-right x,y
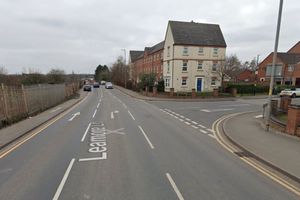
129,41 -> 164,84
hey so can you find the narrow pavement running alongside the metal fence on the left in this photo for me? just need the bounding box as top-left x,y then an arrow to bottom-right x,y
0,90 -> 87,149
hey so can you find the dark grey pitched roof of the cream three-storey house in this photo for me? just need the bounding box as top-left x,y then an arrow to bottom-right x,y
169,21 -> 227,47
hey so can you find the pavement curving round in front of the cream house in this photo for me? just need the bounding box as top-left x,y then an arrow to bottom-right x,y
114,85 -> 268,102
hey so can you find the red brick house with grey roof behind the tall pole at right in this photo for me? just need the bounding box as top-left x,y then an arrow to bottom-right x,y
258,42 -> 300,87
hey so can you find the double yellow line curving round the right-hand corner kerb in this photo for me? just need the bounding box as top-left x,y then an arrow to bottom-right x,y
212,112 -> 300,196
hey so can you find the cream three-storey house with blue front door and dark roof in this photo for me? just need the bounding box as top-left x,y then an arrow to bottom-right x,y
163,21 -> 226,92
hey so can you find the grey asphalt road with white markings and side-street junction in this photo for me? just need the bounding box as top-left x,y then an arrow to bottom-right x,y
0,88 -> 299,200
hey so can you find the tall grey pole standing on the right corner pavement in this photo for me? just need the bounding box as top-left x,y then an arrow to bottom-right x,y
266,0 -> 283,131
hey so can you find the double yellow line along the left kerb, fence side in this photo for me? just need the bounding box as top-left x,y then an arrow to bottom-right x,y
0,96 -> 88,159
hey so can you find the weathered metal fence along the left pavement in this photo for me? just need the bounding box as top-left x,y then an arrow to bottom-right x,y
0,83 -> 80,127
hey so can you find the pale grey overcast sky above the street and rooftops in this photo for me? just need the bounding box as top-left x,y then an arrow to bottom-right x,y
0,0 -> 300,73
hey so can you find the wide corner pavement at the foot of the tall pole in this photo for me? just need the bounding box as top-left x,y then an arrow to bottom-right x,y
223,112 -> 300,181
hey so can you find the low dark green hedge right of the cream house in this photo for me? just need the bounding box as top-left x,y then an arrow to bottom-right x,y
226,84 -> 269,94
